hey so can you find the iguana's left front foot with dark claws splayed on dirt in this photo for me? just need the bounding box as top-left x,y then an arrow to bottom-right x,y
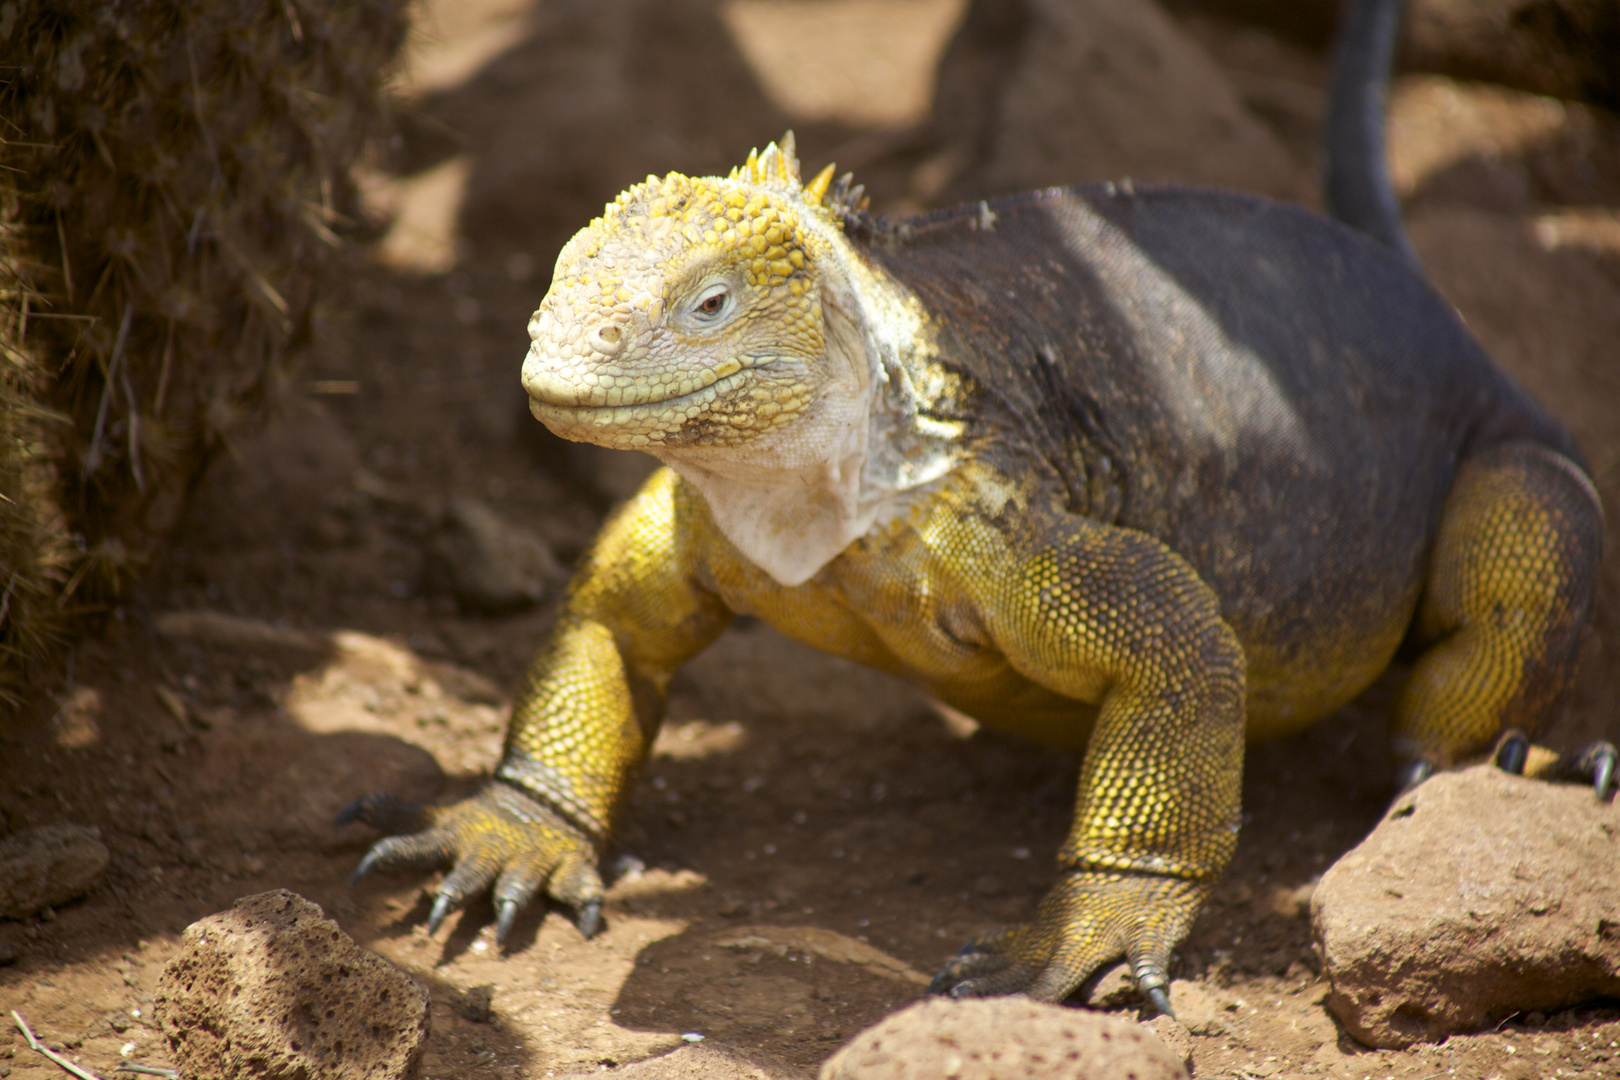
337,780 -> 603,946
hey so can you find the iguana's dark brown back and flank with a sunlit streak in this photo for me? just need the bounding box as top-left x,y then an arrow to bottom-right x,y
852,186 -> 1570,667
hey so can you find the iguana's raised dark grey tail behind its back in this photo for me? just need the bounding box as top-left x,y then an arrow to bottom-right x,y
1324,0 -> 1418,266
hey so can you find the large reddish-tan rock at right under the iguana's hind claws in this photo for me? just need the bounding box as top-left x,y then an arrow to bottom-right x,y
1311,766 -> 1620,1049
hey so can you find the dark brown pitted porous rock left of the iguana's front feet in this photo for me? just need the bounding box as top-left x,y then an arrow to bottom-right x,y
154,889 -> 428,1080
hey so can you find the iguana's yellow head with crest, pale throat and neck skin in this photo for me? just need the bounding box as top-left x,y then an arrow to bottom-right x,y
523,134 -> 956,585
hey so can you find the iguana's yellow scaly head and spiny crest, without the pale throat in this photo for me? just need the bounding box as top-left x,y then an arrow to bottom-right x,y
523,136 -> 865,469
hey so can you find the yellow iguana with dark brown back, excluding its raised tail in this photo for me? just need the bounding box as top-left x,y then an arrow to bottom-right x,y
345,0 -> 1615,1012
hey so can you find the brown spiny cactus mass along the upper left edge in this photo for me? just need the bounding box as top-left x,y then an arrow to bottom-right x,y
0,0 -> 407,709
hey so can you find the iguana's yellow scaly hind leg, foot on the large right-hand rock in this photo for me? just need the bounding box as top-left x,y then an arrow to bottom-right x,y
1395,444 -> 1614,795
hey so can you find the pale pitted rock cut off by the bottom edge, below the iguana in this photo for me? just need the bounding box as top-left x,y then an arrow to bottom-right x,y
820,997 -> 1187,1080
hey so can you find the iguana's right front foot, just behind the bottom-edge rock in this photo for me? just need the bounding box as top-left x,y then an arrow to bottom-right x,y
928,870 -> 1209,1014
